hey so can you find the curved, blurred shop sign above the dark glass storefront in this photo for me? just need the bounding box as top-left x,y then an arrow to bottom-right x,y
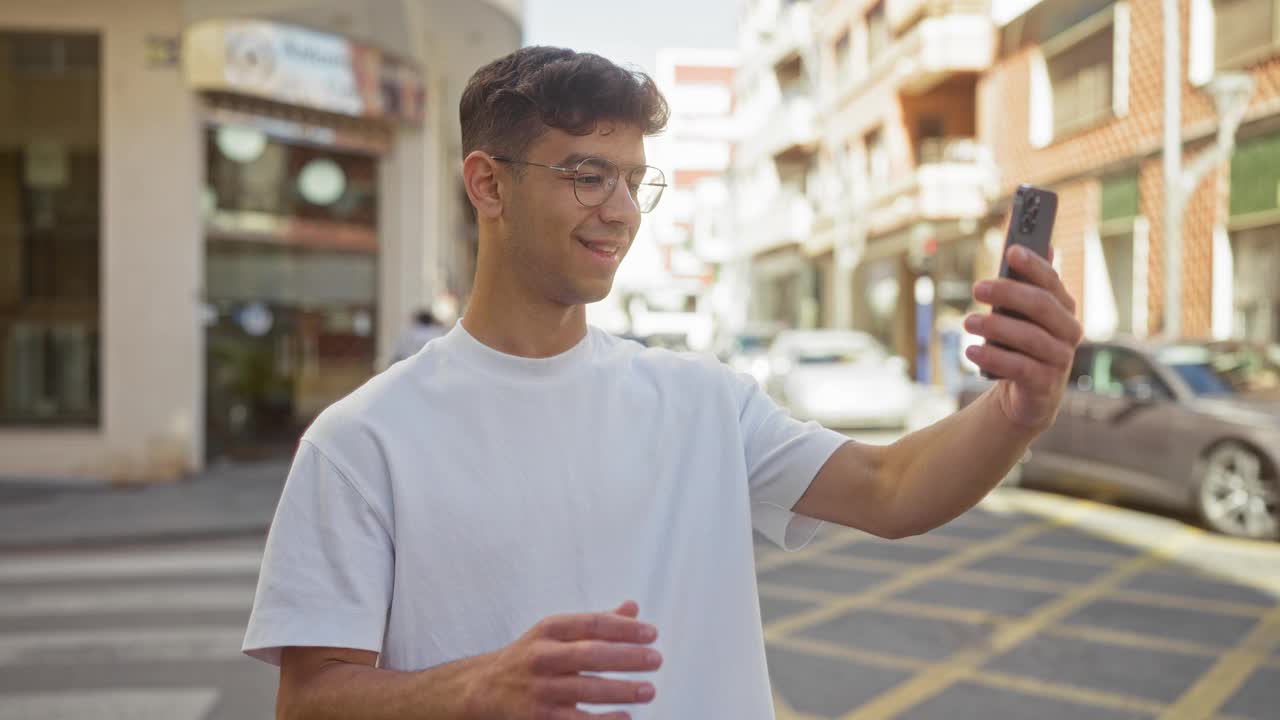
184,20 -> 425,122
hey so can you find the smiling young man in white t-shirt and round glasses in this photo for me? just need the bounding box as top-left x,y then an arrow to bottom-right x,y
244,47 -> 1080,720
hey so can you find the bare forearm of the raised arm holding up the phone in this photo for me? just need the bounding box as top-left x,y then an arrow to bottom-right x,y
882,392 -> 1038,536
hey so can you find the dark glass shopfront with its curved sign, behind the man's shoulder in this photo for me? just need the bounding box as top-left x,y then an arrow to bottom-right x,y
186,20 -> 425,460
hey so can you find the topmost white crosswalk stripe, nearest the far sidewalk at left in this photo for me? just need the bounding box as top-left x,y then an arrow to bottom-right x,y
0,548 -> 262,583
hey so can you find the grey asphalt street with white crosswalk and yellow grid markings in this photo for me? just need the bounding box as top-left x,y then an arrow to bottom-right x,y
0,489 -> 1280,720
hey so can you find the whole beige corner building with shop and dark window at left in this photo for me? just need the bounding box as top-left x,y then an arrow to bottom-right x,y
0,0 -> 521,483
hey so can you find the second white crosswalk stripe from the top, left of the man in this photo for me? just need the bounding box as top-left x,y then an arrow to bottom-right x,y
0,584 -> 253,618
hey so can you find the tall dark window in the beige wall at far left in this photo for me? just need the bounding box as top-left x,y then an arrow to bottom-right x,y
0,32 -> 101,427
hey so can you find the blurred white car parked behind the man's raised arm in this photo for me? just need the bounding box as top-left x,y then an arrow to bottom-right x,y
769,331 -> 915,429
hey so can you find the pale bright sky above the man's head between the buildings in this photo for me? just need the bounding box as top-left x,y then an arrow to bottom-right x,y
525,0 -> 740,74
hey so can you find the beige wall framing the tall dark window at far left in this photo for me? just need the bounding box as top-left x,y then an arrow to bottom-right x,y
0,0 -> 204,480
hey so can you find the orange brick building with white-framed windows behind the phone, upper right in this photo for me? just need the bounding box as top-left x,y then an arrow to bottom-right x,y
978,0 -> 1280,341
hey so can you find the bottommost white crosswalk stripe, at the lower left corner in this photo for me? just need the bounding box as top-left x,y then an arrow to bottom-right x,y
0,688 -> 219,720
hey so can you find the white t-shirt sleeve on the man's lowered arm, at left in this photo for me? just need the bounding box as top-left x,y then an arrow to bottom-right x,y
243,439 -> 394,665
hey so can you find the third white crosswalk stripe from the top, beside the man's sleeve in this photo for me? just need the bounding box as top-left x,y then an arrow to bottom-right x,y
0,625 -> 244,666
